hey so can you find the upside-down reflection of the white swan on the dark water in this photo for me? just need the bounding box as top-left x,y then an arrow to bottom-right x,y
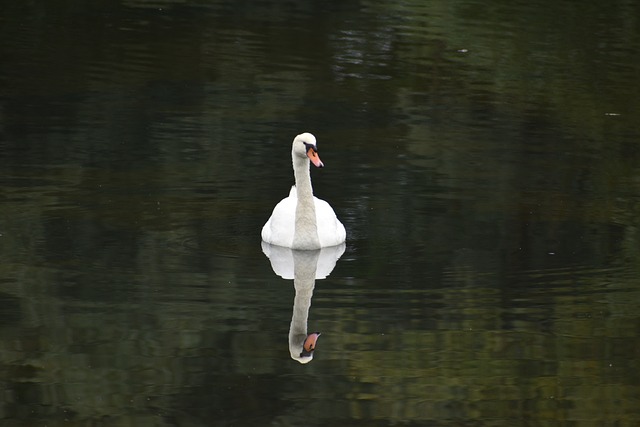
262,242 -> 345,363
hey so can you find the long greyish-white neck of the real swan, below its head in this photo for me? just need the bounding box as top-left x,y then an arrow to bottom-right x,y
292,154 -> 320,249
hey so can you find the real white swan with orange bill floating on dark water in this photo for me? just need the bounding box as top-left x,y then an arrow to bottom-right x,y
262,132 -> 347,250
